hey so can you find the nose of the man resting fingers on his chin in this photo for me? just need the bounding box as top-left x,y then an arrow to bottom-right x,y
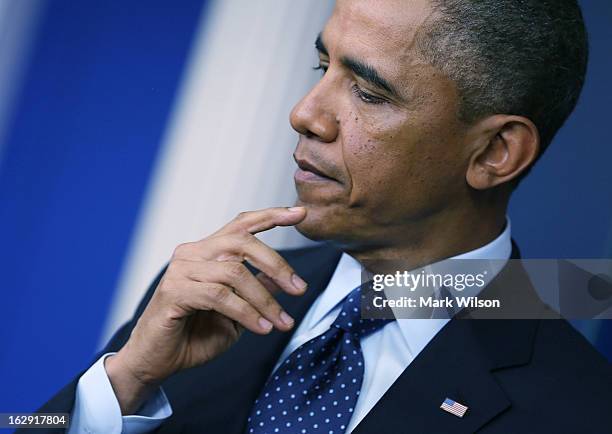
290,75 -> 339,143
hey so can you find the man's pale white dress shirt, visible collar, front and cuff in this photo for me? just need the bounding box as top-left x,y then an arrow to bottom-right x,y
68,220 -> 512,434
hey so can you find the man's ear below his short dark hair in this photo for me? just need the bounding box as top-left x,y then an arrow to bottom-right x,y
466,115 -> 540,190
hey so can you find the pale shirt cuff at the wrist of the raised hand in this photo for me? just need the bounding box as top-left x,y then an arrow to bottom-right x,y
68,353 -> 172,434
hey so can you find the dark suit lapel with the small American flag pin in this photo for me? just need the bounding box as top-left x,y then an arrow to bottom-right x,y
354,320 -> 510,434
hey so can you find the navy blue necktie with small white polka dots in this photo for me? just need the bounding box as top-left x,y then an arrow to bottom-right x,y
246,287 -> 389,434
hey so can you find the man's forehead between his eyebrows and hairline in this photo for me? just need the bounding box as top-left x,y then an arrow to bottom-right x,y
323,0 -> 431,63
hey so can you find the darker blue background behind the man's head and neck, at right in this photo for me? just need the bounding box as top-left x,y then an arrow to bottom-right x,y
509,1 -> 612,360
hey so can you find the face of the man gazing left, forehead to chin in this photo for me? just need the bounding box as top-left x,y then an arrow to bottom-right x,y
291,0 -> 469,247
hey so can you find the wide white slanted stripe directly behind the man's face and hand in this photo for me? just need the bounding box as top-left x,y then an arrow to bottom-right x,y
103,0 -> 333,342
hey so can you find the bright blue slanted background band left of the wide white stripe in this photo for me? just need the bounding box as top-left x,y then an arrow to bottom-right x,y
0,0 -> 204,412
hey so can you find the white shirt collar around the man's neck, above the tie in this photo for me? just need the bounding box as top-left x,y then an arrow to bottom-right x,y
308,217 -> 512,354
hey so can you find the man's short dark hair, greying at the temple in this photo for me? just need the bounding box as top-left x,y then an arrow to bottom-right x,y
417,0 -> 589,163
